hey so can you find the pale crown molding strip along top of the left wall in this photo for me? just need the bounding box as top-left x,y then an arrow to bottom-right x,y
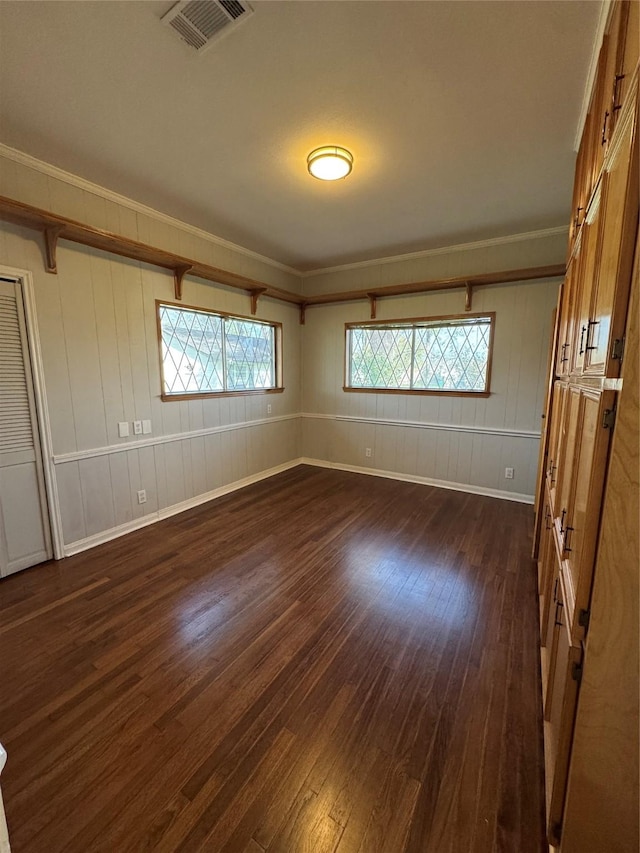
0,142 -> 300,278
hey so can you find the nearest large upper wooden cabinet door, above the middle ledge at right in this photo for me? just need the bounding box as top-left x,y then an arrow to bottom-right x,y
585,87 -> 638,376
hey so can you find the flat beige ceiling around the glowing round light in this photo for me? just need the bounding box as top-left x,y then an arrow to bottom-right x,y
0,0 -> 601,271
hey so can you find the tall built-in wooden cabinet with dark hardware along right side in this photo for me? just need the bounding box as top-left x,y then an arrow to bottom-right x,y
534,0 -> 640,853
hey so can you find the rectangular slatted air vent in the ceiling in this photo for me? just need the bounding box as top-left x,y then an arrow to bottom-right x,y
162,0 -> 253,53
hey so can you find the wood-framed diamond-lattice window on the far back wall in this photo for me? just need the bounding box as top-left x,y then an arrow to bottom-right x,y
344,313 -> 495,396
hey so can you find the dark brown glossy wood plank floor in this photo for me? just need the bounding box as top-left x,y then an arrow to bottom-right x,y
0,467 -> 543,853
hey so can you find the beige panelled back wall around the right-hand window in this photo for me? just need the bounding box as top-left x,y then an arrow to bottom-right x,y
302,234 -> 566,497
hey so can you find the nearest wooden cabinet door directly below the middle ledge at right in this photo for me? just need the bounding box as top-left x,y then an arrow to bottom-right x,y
560,391 -> 615,642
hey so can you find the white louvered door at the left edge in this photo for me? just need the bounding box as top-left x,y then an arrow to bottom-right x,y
0,279 -> 52,577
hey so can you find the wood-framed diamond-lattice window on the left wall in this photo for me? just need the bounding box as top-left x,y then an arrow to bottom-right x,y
156,302 -> 282,400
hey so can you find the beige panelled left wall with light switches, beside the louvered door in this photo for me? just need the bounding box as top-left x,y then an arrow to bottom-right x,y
0,160 -> 300,550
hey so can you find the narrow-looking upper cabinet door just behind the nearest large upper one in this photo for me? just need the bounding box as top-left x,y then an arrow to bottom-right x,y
571,196 -> 600,373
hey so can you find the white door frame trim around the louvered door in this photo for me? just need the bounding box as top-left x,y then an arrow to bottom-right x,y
0,264 -> 64,560
